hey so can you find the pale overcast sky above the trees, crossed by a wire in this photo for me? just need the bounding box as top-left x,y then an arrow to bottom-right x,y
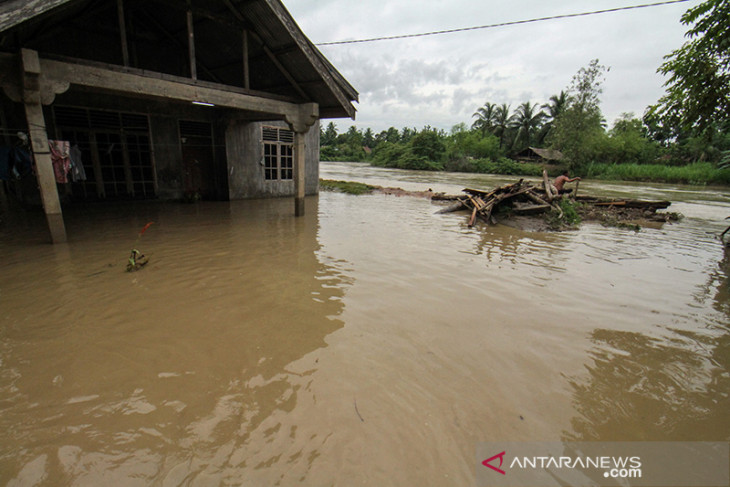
284,0 -> 700,133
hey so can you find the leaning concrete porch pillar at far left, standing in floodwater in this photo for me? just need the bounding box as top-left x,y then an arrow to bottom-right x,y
21,49 -> 66,243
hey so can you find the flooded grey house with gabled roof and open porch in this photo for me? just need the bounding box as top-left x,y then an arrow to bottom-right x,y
0,0 -> 358,242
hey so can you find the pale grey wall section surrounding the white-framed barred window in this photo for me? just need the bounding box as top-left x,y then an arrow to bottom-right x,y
226,121 -> 319,200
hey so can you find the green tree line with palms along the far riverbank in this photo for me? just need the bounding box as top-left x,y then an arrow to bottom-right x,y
320,0 -> 730,183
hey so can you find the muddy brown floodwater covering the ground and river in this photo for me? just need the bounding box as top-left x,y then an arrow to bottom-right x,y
0,163 -> 730,486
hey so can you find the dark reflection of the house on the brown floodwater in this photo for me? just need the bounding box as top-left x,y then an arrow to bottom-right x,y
0,197 -> 348,485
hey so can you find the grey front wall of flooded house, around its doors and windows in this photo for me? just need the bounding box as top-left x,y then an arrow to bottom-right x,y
2,85 -> 319,203
